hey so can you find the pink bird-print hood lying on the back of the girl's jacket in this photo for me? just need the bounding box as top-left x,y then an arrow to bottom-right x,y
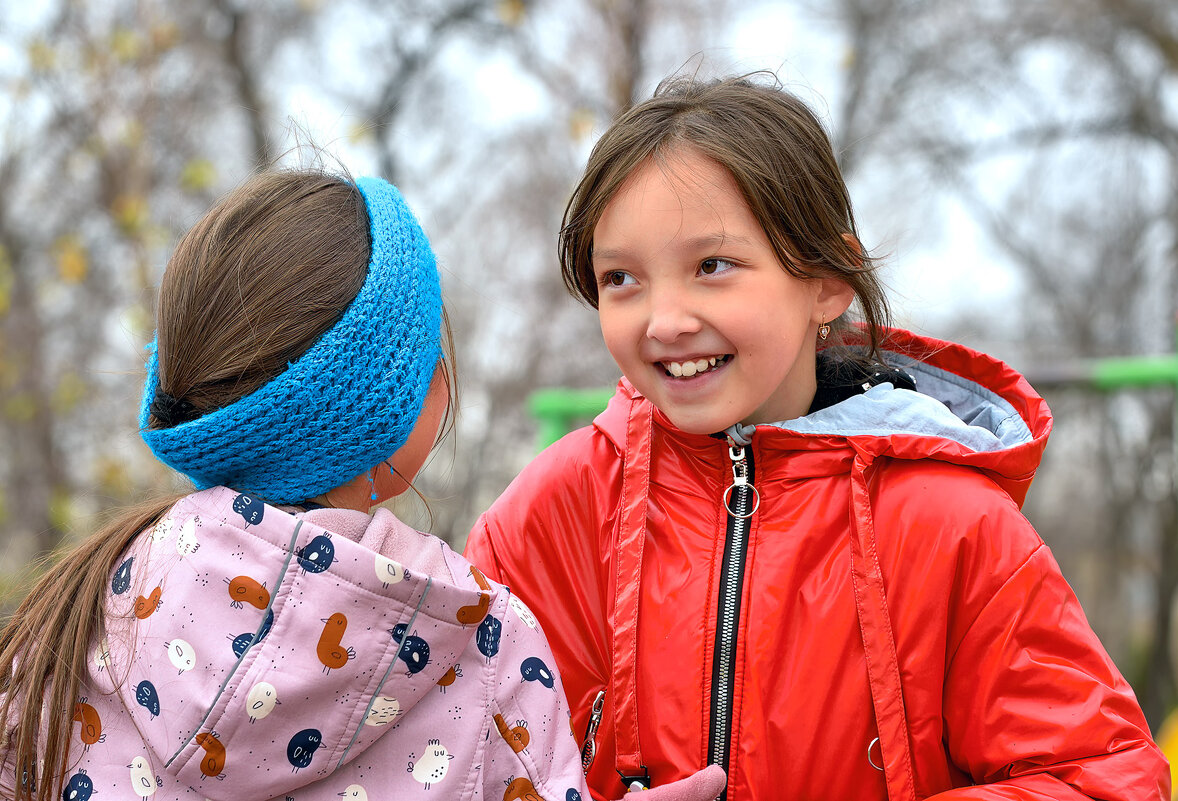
99,488 -> 495,801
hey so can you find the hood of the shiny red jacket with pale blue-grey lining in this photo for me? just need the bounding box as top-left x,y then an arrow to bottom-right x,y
594,330 -> 1052,504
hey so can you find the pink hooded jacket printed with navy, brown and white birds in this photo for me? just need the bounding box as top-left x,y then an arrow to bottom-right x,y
44,488 -> 588,801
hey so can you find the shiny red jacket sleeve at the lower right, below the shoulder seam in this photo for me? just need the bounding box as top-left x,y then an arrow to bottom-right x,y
933,541 -> 1170,801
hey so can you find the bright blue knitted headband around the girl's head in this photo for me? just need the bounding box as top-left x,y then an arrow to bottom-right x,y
139,178 -> 442,503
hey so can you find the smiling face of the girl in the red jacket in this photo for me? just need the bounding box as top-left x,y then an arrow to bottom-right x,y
593,148 -> 853,433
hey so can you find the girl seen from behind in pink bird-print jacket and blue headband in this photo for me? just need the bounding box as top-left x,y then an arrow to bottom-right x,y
0,171 -> 723,801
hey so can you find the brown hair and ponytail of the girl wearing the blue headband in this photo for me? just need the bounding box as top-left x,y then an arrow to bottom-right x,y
0,170 -> 455,799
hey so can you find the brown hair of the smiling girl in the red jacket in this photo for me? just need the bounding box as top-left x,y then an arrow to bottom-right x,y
558,73 -> 889,359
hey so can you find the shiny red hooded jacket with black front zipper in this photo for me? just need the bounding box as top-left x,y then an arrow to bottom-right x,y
466,332 -> 1170,801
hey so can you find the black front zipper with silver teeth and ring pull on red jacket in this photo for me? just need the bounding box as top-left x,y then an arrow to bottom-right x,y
708,437 -> 761,801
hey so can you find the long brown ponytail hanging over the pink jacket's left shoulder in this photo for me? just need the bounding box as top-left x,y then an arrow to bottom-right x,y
0,496 -> 179,801
